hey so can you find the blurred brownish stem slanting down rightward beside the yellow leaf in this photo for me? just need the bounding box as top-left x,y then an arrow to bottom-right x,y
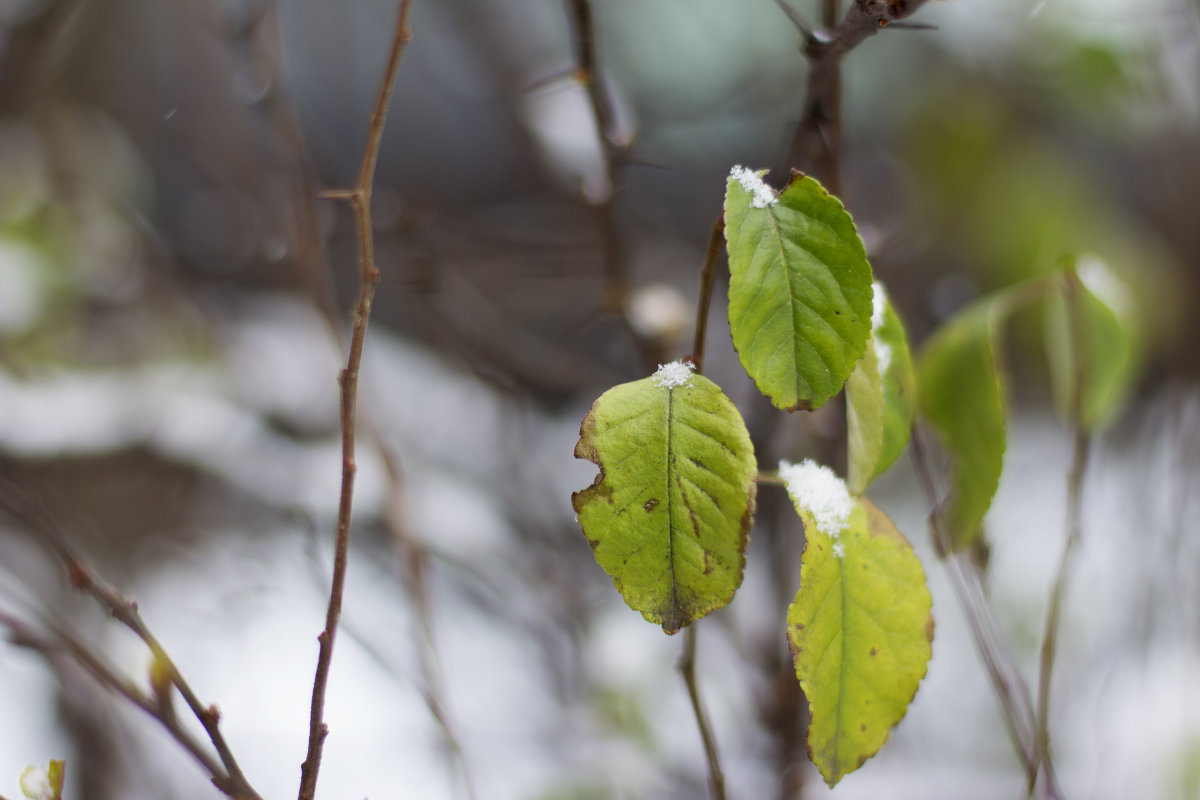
911,426 -> 1061,798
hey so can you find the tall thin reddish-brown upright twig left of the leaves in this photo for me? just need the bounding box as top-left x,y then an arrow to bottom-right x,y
299,0 -> 413,800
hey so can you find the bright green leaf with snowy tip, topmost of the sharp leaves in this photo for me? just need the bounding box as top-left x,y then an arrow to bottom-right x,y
725,167 -> 871,410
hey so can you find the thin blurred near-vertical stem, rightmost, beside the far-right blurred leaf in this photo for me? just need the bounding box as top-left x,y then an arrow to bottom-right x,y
1025,270 -> 1092,796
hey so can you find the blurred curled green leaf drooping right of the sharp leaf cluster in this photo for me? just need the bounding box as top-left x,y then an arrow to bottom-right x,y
917,295 -> 1006,551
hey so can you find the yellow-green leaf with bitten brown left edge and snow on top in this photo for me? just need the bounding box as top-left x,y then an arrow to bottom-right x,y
571,362 -> 757,633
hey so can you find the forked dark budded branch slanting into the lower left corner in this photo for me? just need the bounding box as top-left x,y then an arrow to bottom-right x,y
0,483 -> 260,800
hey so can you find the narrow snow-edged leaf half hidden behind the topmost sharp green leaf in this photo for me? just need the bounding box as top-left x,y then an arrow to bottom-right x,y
846,283 -> 917,494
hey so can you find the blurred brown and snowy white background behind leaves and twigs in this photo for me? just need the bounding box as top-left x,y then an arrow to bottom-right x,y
0,0 -> 1200,800
